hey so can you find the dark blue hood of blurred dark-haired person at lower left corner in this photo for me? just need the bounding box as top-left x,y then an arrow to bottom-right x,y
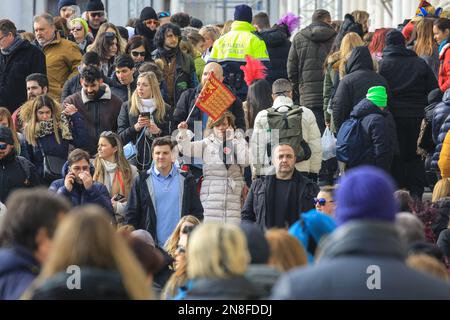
0,245 -> 40,277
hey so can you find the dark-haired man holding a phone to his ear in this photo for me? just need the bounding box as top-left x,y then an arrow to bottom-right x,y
49,149 -> 114,215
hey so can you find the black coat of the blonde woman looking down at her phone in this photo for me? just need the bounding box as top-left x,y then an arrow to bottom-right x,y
117,102 -> 171,170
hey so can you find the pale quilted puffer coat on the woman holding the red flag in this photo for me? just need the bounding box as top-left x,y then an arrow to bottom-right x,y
177,131 -> 249,223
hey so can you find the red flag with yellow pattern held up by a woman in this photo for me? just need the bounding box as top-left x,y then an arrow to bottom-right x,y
195,72 -> 236,121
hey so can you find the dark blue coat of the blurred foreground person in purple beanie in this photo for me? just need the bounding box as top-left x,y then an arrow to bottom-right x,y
272,222 -> 450,300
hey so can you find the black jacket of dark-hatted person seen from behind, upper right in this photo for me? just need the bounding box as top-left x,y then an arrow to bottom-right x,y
379,45 -> 438,118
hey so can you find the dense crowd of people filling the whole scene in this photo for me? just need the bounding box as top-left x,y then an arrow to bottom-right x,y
0,0 -> 450,300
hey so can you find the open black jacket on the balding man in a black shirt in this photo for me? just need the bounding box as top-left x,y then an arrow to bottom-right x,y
241,170 -> 319,228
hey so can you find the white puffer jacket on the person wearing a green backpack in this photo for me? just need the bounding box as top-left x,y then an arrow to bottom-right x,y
250,96 -> 322,176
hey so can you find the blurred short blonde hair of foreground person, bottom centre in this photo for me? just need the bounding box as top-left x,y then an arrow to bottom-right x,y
187,222 -> 250,279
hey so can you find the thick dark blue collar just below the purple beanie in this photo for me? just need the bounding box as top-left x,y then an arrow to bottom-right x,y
318,221 -> 406,263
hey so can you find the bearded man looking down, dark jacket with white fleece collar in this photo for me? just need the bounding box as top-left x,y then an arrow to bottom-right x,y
63,66 -> 122,156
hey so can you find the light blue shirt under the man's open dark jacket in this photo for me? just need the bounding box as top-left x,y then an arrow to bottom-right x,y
149,166 -> 180,247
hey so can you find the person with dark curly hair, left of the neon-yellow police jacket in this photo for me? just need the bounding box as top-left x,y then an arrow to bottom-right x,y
152,23 -> 198,106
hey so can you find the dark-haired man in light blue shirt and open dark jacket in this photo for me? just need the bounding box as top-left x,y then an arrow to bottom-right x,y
125,137 -> 203,247
